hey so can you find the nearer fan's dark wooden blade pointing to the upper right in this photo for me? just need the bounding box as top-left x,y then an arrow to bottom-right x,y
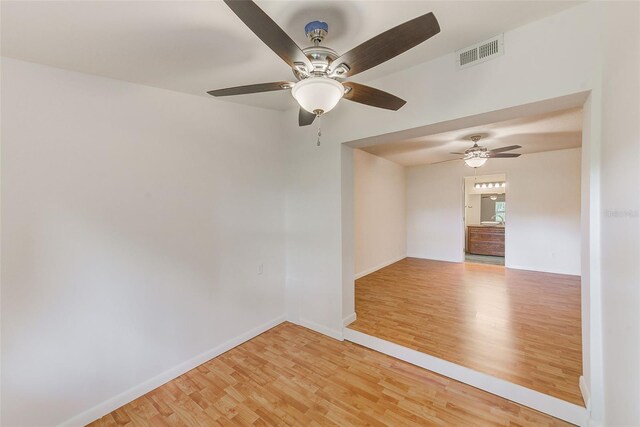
330,12 -> 440,77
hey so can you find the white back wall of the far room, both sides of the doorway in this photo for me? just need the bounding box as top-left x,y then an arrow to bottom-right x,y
407,148 -> 581,275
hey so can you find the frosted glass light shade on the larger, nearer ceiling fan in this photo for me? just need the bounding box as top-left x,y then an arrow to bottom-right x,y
291,77 -> 344,114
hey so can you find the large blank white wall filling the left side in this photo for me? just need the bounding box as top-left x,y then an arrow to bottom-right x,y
1,58 -> 285,426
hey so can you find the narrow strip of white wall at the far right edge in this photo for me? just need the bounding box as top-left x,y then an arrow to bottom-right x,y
600,2 -> 640,426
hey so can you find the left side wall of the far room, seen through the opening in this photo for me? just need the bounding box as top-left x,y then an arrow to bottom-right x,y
353,150 -> 407,277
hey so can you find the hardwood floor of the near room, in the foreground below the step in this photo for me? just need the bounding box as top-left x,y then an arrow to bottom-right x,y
91,323 -> 569,427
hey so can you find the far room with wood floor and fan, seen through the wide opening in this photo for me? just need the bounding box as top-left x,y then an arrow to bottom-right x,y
348,107 -> 585,406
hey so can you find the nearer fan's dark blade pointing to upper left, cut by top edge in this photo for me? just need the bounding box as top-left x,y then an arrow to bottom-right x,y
224,0 -> 313,72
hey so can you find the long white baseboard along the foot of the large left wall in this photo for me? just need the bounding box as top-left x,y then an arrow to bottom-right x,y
60,315 -> 285,426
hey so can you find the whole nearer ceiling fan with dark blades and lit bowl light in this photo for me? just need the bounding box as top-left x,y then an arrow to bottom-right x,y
207,0 -> 440,126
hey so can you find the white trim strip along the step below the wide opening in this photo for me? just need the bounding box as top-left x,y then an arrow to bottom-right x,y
344,328 -> 589,426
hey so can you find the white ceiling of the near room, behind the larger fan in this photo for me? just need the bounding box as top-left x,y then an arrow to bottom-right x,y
0,0 -> 579,110
